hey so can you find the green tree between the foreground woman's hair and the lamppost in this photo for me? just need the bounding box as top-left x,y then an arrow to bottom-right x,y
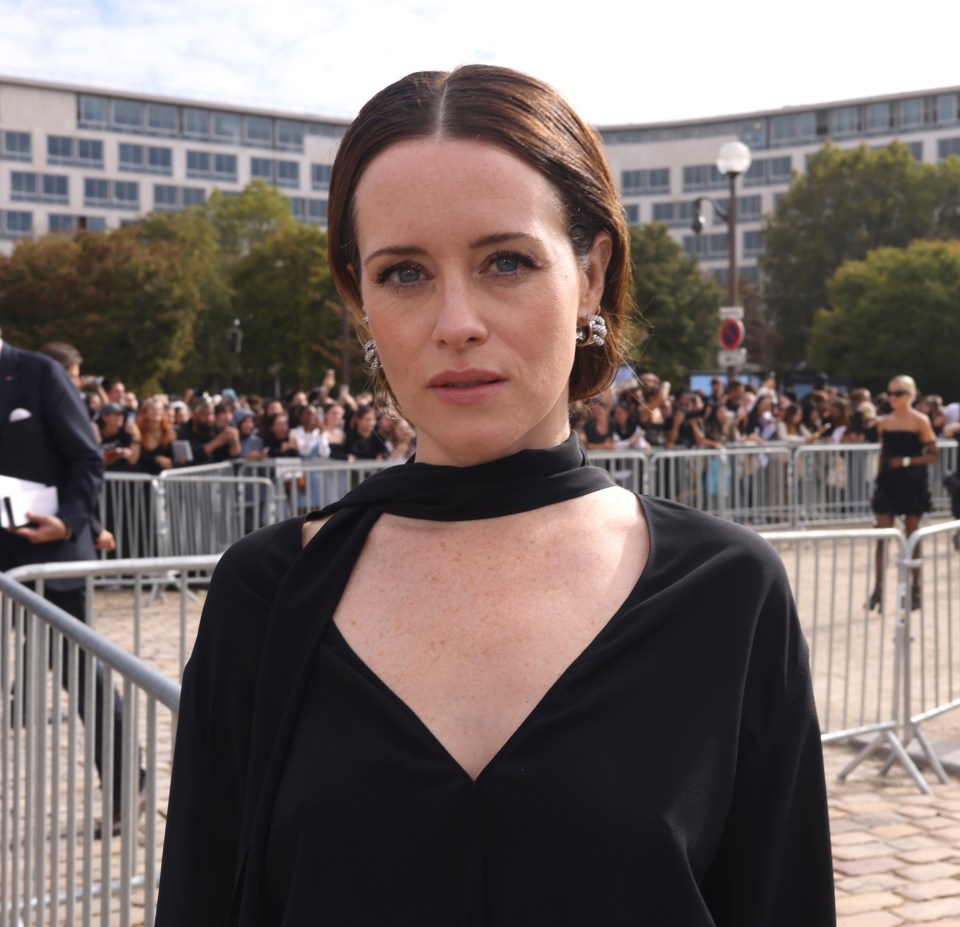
630,224 -> 723,383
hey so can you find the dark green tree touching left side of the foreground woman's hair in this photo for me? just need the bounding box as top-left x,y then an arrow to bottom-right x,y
231,223 -> 342,388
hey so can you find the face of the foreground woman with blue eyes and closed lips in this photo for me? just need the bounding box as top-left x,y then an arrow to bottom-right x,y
355,138 -> 610,466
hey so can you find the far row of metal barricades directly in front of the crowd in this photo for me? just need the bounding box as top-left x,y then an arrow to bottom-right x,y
101,440 -> 957,559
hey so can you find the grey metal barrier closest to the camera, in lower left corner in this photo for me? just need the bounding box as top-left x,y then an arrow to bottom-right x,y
0,563 -> 179,927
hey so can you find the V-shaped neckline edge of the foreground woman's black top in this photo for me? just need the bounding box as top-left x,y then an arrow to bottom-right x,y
325,495 -> 656,786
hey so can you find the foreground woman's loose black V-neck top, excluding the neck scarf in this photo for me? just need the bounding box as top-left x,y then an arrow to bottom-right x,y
157,438 -> 835,927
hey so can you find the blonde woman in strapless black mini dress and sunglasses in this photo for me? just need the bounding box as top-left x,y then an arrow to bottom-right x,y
867,375 -> 940,609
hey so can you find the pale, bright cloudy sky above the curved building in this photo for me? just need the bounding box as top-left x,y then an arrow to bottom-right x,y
0,0 -> 960,126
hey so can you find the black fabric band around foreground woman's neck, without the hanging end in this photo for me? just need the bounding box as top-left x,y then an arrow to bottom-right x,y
307,433 -> 616,521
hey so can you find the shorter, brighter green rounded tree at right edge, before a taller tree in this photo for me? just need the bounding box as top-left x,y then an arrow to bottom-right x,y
810,241 -> 960,396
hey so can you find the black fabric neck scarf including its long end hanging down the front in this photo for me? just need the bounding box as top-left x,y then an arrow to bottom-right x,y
228,434 -> 616,927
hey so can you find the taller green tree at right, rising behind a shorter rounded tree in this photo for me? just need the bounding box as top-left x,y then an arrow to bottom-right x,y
760,142 -> 960,364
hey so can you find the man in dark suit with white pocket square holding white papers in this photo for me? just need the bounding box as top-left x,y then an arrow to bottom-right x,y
0,337 -> 133,840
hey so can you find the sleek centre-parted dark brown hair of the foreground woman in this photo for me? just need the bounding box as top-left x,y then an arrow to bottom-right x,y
328,64 -> 632,401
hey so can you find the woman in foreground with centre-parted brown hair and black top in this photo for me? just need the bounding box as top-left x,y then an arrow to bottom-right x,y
157,65 -> 833,927
